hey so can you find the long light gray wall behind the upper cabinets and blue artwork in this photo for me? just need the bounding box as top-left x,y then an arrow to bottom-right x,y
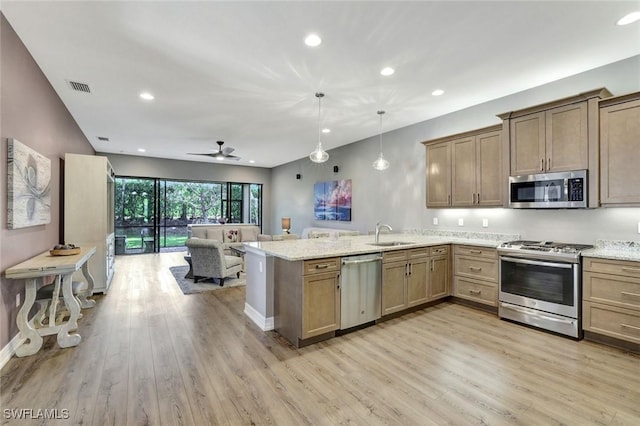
272,56 -> 640,243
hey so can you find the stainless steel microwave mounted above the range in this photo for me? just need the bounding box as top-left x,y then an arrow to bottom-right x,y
509,170 -> 587,209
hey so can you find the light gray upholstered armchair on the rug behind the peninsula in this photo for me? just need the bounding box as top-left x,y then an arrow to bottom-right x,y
186,238 -> 242,286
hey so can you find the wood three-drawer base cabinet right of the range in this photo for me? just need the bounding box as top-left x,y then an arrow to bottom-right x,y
582,257 -> 640,350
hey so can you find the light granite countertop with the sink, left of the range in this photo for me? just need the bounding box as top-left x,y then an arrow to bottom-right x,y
244,232 -> 519,261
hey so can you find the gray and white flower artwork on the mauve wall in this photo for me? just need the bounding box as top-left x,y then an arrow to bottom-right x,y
7,139 -> 51,229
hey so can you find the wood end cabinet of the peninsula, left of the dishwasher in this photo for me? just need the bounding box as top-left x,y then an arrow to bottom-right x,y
274,257 -> 340,347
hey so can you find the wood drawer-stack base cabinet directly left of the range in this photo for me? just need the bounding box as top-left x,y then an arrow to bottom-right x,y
453,245 -> 498,307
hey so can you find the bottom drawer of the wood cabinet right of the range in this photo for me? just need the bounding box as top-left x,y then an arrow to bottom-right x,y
582,301 -> 640,343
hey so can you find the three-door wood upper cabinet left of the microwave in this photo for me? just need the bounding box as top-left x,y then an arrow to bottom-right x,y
424,126 -> 504,207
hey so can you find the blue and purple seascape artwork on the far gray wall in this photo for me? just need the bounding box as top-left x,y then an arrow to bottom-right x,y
313,179 -> 351,222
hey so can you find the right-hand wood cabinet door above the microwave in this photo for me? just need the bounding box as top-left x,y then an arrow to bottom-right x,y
545,102 -> 589,172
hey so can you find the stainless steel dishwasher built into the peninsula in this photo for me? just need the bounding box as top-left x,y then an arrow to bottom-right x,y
340,253 -> 382,330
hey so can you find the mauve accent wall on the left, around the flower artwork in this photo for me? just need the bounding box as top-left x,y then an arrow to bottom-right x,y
0,14 -> 95,349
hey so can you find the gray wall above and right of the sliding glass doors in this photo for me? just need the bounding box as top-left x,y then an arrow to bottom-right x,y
101,153 -> 272,234
